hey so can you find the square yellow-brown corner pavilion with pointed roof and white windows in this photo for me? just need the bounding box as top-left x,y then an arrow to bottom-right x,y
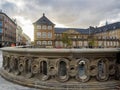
33,14 -> 55,47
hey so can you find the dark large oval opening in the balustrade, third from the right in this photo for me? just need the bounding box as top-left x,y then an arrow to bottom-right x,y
58,61 -> 67,79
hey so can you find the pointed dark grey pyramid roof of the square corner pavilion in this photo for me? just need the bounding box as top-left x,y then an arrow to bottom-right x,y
33,13 -> 54,25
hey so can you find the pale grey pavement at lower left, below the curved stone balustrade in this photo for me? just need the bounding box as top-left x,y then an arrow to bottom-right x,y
0,51 -> 38,90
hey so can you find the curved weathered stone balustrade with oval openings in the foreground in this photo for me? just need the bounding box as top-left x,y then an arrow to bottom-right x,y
1,48 -> 120,90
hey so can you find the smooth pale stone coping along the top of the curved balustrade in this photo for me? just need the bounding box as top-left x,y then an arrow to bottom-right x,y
0,47 -> 120,53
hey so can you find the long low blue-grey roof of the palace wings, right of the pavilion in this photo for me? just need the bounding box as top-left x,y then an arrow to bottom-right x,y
55,22 -> 120,34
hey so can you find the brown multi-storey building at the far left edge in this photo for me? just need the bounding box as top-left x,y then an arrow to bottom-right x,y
0,12 -> 17,46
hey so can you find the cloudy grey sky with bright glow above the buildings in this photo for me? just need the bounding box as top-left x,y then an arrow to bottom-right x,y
0,0 -> 120,40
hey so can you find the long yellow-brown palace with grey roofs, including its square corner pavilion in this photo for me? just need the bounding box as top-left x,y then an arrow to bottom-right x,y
33,14 -> 120,48
